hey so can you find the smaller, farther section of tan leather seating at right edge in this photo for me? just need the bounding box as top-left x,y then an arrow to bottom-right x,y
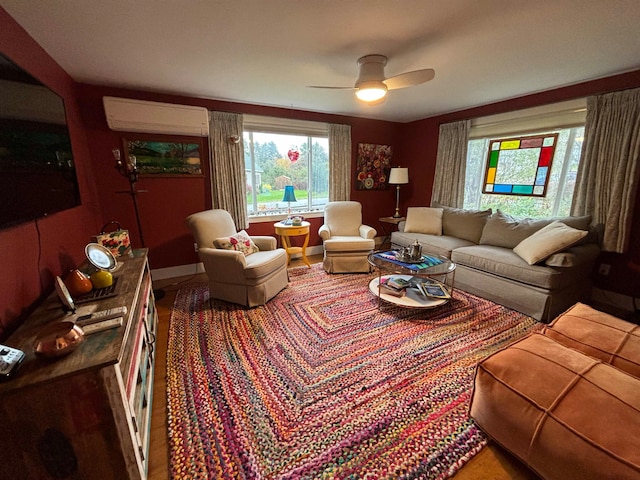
544,303 -> 640,378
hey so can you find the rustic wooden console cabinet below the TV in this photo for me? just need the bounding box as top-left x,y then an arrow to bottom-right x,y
0,249 -> 157,480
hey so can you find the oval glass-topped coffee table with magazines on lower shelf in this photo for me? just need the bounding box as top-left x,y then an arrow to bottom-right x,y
368,250 -> 456,308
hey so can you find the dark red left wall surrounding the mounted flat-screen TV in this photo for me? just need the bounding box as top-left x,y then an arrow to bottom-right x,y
0,8 -> 100,338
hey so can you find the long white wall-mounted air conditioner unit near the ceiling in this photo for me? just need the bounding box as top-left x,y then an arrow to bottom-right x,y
102,97 -> 209,137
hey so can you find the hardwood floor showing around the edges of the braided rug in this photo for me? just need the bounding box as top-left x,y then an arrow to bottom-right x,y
148,255 -> 538,480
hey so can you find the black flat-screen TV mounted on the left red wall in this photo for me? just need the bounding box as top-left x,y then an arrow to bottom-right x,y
0,54 -> 80,229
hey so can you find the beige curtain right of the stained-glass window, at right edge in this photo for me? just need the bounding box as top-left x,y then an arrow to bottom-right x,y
571,89 -> 640,253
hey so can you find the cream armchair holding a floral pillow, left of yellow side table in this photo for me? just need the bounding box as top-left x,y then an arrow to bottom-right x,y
187,210 -> 289,307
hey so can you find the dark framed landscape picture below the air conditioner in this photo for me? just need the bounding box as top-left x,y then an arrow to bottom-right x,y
124,139 -> 202,176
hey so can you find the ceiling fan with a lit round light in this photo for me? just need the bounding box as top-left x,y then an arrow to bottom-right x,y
310,55 -> 436,105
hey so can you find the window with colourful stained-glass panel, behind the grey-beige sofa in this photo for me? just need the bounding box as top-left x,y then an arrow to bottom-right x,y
464,101 -> 584,218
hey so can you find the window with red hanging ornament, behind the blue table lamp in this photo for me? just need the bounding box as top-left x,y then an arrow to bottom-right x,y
243,115 -> 329,217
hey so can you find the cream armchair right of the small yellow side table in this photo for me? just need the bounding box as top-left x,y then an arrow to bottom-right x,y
318,201 -> 376,273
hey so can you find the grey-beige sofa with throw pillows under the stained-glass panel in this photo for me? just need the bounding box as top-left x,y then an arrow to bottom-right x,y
391,204 -> 600,322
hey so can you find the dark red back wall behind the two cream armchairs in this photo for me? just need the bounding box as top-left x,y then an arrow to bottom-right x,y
78,85 -> 402,268
